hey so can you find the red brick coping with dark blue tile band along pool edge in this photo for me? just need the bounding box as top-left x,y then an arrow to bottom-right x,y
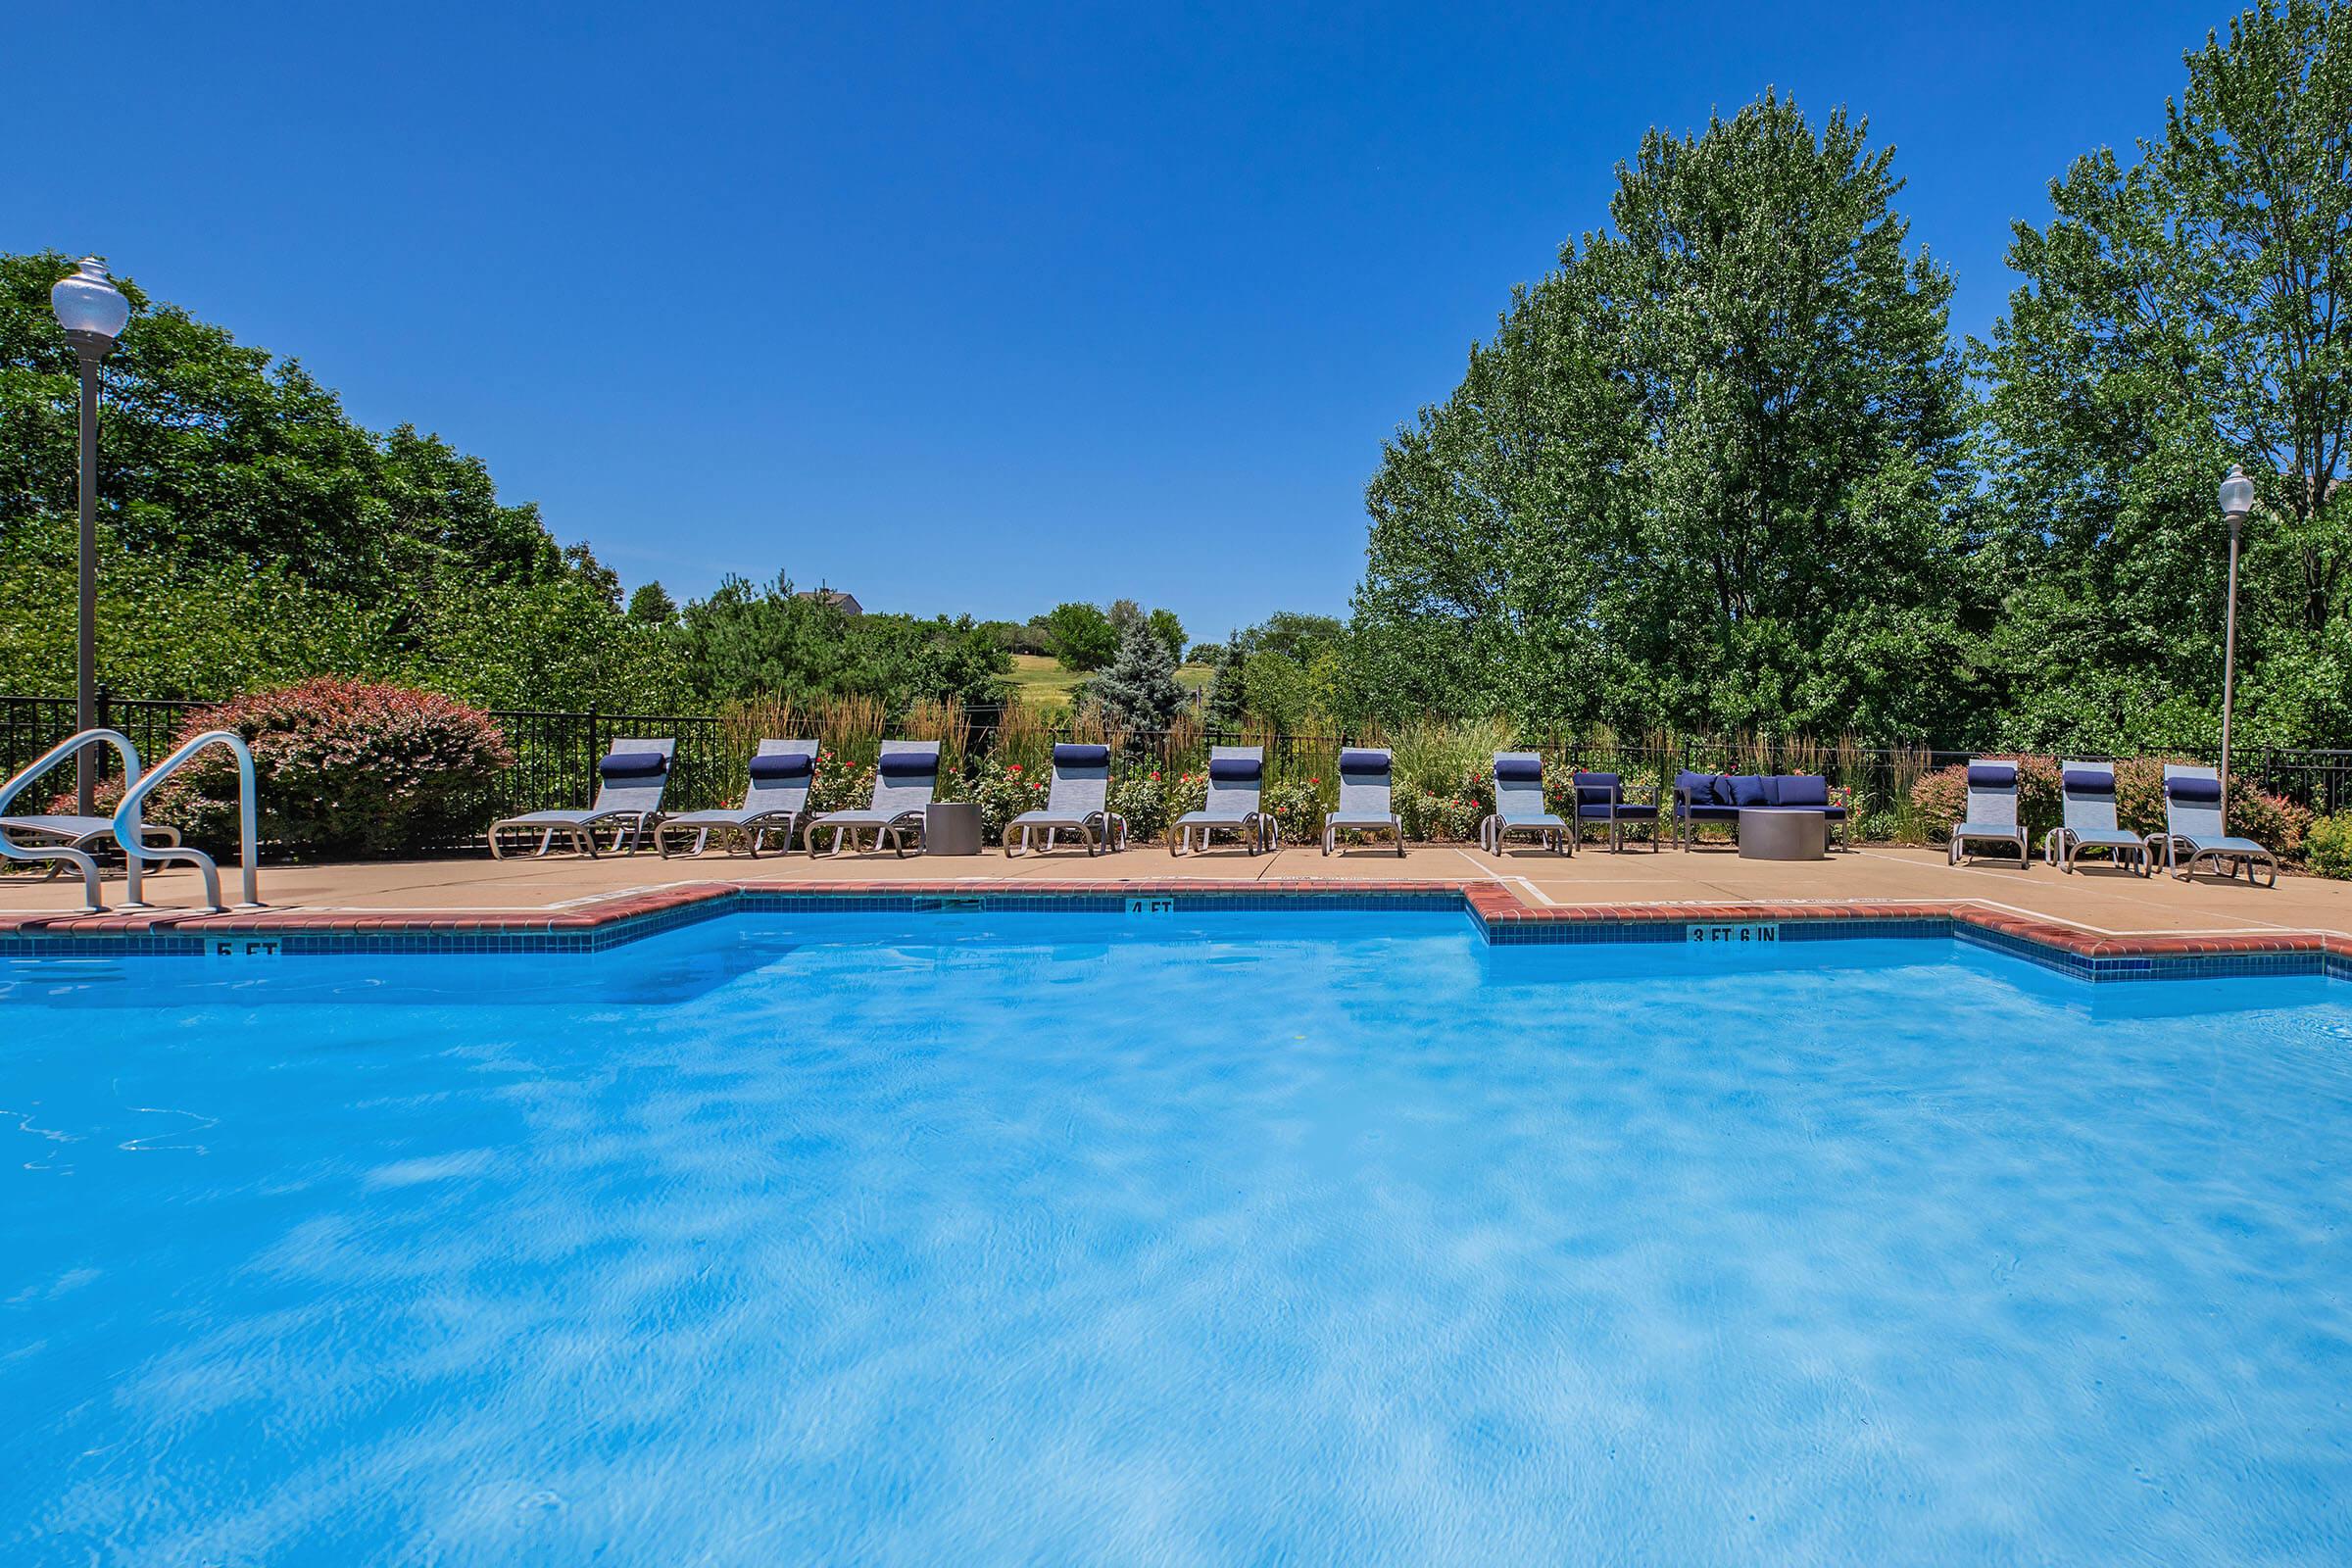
0,877 -> 2352,980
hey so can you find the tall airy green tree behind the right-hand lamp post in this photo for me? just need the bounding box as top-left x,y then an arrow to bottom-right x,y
1974,0 -> 2352,750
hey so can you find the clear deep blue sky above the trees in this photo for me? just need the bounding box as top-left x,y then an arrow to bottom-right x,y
0,0 -> 2230,635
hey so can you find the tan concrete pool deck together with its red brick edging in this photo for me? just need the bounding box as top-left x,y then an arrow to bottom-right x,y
0,844 -> 2352,953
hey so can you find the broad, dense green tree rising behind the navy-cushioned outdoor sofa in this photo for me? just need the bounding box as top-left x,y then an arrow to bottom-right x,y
1354,94 -> 1978,738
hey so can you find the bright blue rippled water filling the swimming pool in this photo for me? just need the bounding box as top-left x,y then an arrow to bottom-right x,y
0,914 -> 2352,1568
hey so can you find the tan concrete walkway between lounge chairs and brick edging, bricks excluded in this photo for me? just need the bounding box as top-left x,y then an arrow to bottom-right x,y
0,844 -> 2352,936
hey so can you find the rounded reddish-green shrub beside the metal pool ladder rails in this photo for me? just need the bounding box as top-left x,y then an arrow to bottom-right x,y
133,677 -> 515,856
